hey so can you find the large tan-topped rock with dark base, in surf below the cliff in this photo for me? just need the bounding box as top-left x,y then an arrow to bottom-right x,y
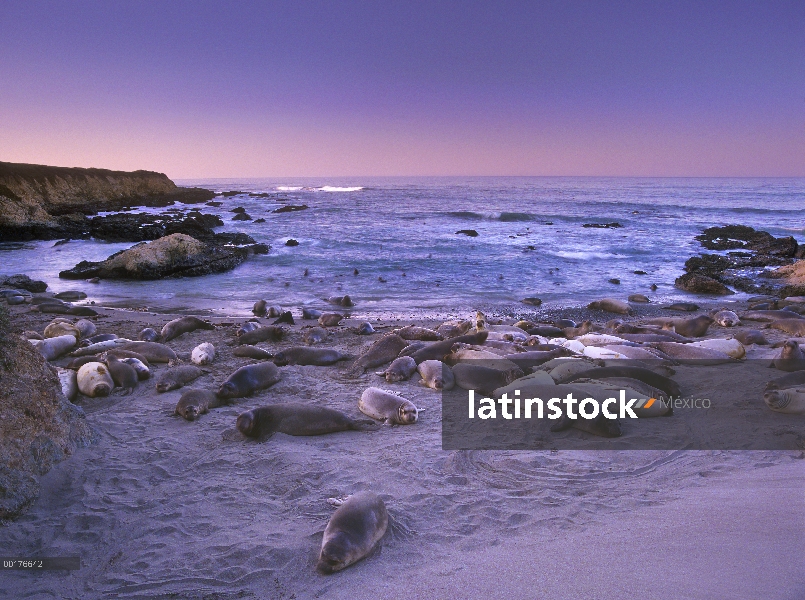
59,233 -> 254,279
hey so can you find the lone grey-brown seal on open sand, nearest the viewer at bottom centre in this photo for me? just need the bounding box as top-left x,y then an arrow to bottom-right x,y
316,492 -> 389,575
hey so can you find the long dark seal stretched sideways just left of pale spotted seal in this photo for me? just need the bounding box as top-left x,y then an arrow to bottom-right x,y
236,403 -> 377,439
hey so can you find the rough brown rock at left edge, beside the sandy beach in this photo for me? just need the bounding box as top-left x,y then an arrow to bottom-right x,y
0,307 -> 97,519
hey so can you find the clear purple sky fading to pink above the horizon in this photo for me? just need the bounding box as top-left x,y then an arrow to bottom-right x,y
0,0 -> 805,178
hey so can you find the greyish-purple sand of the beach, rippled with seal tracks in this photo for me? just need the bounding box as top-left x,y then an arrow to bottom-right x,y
0,298 -> 805,598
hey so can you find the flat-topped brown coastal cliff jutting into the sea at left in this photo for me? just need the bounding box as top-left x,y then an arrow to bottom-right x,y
0,162 -> 214,241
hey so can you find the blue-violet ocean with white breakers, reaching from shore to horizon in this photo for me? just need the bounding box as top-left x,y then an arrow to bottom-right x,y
0,177 -> 805,317
